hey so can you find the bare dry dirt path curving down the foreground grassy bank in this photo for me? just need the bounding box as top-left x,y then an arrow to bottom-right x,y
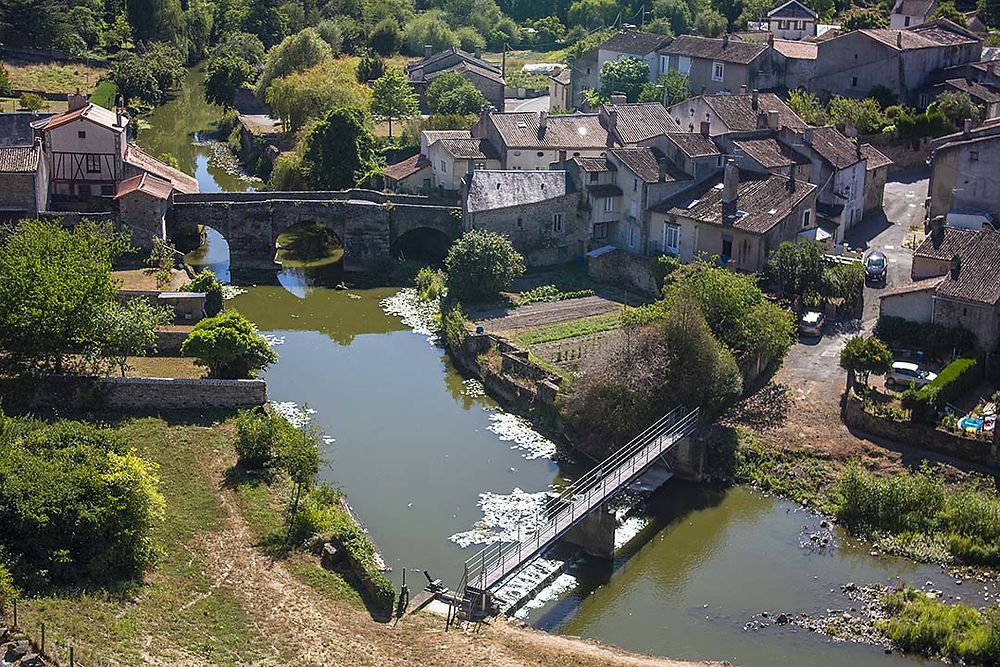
162,448 -> 720,667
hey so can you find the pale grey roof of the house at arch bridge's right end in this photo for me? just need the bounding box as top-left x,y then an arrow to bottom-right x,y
465,169 -> 567,213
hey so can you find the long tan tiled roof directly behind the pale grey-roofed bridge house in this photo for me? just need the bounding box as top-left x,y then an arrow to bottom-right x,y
490,111 -> 608,149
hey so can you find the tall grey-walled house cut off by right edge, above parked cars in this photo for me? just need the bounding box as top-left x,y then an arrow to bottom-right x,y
928,119 -> 1000,220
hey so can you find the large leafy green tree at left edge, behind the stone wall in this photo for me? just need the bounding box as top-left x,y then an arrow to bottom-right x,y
0,220 -> 129,373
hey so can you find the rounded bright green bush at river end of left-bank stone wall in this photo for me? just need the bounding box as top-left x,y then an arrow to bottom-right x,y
181,312 -> 278,379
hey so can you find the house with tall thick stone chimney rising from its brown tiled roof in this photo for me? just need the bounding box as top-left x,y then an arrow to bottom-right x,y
650,160 -> 816,272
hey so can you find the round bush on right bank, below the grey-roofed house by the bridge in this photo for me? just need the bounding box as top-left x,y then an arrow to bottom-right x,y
445,229 -> 524,301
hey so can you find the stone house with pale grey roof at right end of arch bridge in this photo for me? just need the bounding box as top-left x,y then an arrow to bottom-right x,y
462,170 -> 588,266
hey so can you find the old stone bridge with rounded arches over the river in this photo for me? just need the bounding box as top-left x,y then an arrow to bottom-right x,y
167,189 -> 461,272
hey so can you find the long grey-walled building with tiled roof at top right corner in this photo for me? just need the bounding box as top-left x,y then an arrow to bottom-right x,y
810,19 -> 982,106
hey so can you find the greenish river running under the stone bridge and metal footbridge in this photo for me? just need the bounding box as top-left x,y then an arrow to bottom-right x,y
148,68 -> 992,667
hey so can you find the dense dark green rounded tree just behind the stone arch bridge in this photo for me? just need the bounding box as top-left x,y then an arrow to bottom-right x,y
304,107 -> 379,190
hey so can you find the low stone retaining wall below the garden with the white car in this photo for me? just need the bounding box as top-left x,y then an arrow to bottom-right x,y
842,392 -> 1000,467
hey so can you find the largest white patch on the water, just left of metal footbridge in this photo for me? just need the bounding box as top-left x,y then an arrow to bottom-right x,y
448,488 -> 552,549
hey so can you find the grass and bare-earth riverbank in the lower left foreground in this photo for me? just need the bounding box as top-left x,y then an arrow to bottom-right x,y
9,413 -> 720,667
